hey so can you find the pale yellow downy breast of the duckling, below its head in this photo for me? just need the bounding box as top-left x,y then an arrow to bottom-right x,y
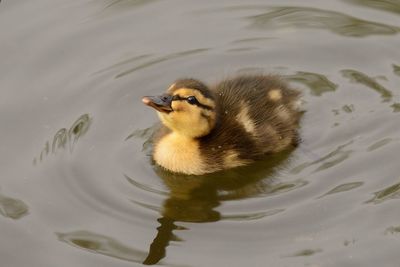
153,132 -> 207,175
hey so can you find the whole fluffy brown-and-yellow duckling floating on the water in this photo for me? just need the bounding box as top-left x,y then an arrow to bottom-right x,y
142,75 -> 302,175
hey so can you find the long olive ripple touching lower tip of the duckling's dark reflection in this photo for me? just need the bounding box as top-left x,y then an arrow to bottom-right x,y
56,231 -> 147,263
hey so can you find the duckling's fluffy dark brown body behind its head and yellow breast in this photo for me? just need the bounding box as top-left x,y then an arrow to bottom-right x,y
200,75 -> 301,171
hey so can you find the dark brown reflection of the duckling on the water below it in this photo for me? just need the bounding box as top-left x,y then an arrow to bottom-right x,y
143,151 -> 290,265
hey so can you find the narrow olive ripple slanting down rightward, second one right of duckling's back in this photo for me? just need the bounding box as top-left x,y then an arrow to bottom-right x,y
340,69 -> 393,102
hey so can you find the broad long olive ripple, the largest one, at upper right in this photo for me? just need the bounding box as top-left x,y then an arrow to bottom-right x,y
248,7 -> 400,37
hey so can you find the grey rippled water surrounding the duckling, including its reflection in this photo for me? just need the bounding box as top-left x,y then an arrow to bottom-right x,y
0,0 -> 400,266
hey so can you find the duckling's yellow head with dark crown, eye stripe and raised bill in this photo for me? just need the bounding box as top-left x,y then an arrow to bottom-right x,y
142,79 -> 216,138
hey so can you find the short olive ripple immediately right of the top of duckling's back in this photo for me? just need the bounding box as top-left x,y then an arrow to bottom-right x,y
284,71 -> 338,96
